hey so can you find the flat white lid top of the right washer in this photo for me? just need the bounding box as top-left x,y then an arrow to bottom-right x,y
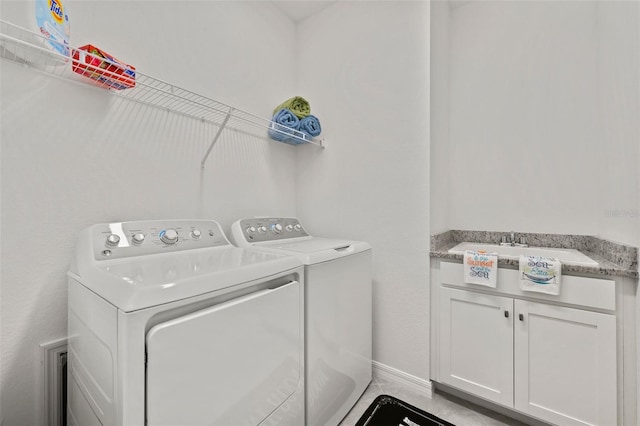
251,237 -> 371,265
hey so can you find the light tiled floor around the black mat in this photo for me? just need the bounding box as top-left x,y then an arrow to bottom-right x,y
339,378 -> 524,426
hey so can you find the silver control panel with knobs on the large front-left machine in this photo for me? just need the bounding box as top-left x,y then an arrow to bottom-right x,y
90,220 -> 229,260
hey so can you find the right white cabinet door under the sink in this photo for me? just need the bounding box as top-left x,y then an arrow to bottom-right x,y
514,300 -> 617,425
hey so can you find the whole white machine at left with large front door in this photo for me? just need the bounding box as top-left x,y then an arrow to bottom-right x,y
68,220 -> 304,426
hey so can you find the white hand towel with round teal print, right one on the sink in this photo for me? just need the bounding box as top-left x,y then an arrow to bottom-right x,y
520,255 -> 562,295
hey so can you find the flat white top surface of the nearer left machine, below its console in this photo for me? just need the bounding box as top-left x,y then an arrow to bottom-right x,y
69,246 -> 302,312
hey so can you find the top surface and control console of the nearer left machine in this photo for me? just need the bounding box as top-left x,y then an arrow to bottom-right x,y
69,220 -> 302,312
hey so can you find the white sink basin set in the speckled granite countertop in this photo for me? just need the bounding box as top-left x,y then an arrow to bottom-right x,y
449,243 -> 598,266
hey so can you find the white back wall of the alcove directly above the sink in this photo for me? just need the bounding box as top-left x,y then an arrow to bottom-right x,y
449,1 -> 599,233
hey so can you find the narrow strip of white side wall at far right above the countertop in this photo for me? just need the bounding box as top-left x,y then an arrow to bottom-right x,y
596,1 -> 640,245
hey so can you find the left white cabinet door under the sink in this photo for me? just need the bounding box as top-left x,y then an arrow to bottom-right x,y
439,287 -> 513,407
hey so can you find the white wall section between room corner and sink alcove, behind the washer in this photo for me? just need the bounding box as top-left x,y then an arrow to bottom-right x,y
296,1 -> 429,378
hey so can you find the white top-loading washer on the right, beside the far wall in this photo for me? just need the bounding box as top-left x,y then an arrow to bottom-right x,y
231,218 -> 372,426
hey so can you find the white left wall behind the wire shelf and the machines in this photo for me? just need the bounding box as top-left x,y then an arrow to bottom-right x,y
0,1 -> 296,425
